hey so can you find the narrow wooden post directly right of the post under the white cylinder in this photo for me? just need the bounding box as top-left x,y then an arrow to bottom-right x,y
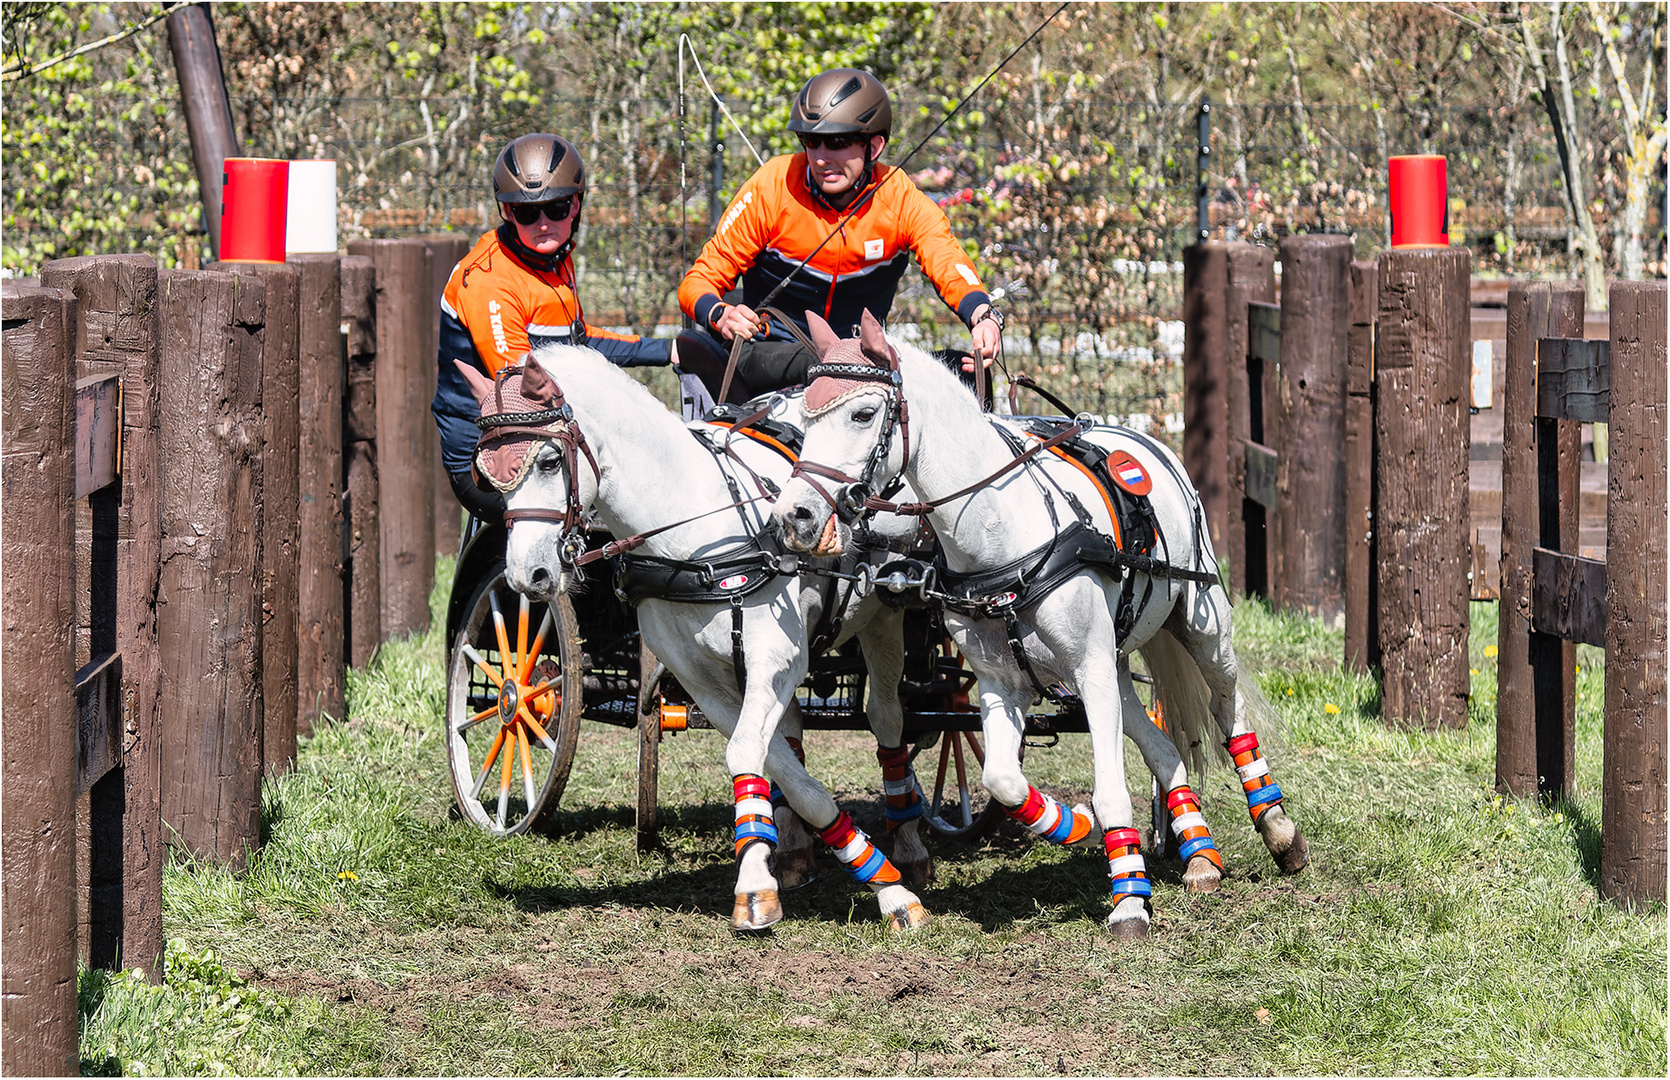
342,255 -> 382,668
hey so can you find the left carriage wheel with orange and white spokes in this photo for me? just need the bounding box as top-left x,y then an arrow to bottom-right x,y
446,563 -> 583,836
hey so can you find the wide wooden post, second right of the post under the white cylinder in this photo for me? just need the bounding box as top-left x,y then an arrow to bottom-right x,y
347,239 -> 438,639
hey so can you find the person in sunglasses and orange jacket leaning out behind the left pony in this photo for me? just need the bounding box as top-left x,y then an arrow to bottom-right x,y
431,134 -> 671,524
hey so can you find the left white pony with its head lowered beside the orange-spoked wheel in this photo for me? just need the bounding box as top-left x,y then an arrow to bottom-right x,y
459,346 -> 932,931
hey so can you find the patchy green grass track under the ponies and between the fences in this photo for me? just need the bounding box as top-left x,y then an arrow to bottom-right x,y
82,566 -> 1667,1077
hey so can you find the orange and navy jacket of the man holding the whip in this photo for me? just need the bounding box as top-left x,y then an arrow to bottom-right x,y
678,154 -> 989,337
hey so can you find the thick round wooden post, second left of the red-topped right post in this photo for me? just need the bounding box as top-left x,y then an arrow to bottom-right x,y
1271,234 -> 1356,629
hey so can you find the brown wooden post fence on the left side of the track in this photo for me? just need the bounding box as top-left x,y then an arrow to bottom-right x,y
0,235 -> 468,1075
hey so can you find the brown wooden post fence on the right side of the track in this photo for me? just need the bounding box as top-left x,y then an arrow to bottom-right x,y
1184,237 -> 1667,903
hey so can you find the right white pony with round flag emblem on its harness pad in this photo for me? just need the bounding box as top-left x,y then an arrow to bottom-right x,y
773,314 -> 1308,936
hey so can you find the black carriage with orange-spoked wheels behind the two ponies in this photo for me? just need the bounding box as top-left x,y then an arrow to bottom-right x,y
446,519 -> 1084,848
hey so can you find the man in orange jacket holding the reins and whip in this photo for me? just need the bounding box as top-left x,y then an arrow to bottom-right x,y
678,67 -> 1002,404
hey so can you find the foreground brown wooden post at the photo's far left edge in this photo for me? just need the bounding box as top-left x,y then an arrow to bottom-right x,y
0,280 -> 80,1077
